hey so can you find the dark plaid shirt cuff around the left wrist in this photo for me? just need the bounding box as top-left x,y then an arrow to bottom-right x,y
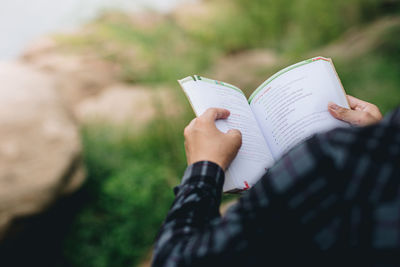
175,161 -> 225,193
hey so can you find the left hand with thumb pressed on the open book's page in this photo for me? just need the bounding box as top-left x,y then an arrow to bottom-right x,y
184,108 -> 242,170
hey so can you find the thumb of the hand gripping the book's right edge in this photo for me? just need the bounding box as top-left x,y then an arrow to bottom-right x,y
328,102 -> 370,125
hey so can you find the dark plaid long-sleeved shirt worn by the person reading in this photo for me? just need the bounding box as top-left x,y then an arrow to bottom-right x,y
153,108 -> 400,267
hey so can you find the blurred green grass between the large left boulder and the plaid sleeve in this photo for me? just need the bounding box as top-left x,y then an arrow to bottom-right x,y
64,115 -> 189,267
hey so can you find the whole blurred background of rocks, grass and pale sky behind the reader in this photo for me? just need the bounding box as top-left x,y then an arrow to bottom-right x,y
0,0 -> 400,267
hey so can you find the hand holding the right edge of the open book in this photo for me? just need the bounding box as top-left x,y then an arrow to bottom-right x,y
328,95 -> 382,126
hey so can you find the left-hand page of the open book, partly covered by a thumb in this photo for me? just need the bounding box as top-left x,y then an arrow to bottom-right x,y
180,76 -> 274,192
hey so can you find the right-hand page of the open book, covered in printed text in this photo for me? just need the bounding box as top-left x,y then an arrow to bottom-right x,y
249,57 -> 349,159
